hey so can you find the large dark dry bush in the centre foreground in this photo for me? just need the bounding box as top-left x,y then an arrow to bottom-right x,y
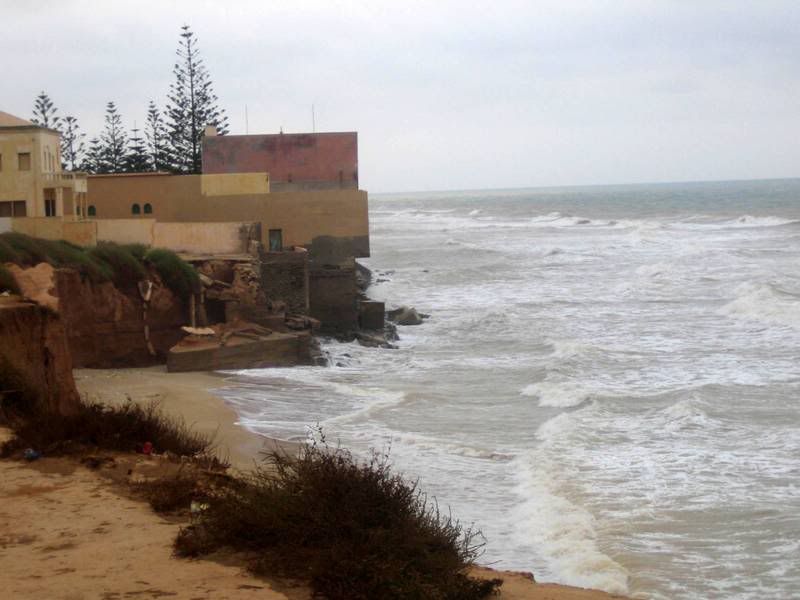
175,438 -> 502,600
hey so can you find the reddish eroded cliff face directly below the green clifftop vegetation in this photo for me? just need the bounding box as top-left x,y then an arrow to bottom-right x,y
9,263 -> 188,368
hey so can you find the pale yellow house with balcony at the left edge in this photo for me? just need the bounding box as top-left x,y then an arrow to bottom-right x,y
0,111 -> 86,218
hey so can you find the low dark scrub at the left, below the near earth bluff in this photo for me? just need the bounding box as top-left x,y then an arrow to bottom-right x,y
4,401 -> 212,456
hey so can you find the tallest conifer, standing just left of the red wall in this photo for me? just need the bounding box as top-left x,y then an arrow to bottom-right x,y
167,25 -> 228,173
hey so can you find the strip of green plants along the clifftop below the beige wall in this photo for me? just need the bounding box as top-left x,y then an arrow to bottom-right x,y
0,232 -> 200,298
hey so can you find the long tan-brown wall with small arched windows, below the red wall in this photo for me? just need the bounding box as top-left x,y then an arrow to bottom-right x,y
88,173 -> 369,259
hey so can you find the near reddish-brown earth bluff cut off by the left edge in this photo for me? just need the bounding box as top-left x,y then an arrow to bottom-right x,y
0,296 -> 80,414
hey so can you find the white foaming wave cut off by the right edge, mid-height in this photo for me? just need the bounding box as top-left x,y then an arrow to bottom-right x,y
718,282 -> 800,329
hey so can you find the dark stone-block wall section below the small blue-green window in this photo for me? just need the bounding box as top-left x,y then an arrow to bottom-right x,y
261,250 -> 309,315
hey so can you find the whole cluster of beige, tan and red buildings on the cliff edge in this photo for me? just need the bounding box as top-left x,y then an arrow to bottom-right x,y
0,113 -> 370,332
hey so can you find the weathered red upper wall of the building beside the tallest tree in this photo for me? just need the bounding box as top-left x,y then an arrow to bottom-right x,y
203,132 -> 358,189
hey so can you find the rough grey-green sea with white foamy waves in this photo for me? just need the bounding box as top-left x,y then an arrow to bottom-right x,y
219,180 -> 800,600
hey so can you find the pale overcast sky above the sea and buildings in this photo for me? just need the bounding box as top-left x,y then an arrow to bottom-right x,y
0,0 -> 800,192
